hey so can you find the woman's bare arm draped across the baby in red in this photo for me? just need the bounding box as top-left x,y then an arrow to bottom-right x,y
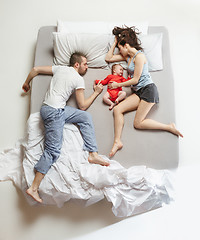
109,54 -> 146,88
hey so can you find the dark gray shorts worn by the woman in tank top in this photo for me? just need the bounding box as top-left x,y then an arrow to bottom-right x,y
133,83 -> 159,103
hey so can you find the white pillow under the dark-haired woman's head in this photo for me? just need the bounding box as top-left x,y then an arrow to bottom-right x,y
109,33 -> 163,72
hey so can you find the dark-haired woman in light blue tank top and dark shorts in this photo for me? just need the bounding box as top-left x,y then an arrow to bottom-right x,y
106,27 -> 183,157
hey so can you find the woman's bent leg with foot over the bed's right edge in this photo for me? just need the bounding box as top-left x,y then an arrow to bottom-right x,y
134,100 -> 183,137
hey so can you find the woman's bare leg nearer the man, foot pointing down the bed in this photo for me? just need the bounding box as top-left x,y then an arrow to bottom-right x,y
109,94 -> 140,157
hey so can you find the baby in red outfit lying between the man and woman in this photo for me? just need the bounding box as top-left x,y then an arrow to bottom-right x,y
95,64 -> 127,110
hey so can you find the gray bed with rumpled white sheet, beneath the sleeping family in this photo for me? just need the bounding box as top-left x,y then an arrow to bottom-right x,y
0,23 -> 178,218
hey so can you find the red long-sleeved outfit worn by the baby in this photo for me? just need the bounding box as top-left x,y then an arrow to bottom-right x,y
96,74 -> 127,102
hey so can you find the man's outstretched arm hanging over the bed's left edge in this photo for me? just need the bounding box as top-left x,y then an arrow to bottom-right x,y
22,66 -> 53,92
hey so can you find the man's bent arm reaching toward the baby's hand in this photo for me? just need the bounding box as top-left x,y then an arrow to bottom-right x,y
76,83 -> 103,111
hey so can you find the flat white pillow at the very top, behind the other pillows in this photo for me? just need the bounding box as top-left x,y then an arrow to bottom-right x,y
57,20 -> 148,34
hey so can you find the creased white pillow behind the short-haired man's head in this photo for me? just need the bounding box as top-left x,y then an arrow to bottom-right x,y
53,32 -> 111,68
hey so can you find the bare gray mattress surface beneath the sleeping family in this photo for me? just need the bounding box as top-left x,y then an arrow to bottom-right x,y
31,26 -> 179,169
